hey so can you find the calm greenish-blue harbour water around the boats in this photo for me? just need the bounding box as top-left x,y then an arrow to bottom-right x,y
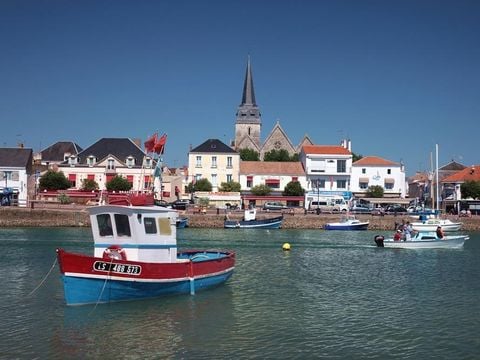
0,228 -> 480,359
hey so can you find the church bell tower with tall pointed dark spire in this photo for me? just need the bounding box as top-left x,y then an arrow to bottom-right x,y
235,56 -> 262,150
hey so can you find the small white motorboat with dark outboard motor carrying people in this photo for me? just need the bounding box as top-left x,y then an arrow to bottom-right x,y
374,231 -> 469,249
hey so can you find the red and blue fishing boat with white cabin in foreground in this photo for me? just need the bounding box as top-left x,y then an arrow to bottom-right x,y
57,205 -> 235,305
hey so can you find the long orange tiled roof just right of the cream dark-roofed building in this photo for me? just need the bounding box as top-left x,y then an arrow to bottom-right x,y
240,161 -> 305,176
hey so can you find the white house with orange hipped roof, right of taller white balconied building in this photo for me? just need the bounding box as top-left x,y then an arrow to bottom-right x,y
350,156 -> 407,198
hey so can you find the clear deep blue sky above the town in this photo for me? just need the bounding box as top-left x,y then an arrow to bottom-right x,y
0,0 -> 480,175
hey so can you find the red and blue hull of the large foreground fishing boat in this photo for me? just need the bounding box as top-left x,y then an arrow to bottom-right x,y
57,249 -> 235,305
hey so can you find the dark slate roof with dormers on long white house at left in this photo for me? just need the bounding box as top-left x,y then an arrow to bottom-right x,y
78,138 -> 145,164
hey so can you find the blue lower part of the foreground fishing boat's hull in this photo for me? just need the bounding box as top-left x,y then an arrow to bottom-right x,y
62,270 -> 233,305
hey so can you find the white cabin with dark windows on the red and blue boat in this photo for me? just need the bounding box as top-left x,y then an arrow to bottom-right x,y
88,205 -> 177,263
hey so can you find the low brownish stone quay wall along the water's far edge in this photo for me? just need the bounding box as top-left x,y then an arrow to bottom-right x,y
0,205 -> 480,231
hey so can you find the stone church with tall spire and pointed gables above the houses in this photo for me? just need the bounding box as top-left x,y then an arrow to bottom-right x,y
232,57 -> 313,160
